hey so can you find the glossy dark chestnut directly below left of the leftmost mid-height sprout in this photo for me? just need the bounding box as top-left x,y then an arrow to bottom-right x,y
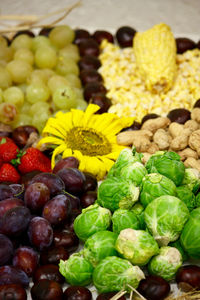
53,231 -> 79,252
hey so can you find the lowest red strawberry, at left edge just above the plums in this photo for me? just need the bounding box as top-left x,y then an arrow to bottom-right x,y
0,163 -> 20,183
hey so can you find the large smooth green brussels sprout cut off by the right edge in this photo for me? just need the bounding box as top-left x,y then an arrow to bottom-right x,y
180,207 -> 200,259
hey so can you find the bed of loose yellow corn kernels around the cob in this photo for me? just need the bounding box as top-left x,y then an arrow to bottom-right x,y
98,40 -> 200,121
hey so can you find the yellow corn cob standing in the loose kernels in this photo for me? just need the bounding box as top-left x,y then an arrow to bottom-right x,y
133,23 -> 177,93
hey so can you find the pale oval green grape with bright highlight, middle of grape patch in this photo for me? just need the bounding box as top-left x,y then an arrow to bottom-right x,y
26,82 -> 50,104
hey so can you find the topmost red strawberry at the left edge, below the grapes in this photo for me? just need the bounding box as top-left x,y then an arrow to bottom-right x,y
0,140 -> 19,162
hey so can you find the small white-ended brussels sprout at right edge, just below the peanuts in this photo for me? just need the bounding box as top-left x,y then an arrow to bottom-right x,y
182,168 -> 200,194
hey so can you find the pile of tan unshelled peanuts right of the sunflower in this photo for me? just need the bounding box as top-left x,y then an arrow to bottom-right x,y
117,107 -> 200,171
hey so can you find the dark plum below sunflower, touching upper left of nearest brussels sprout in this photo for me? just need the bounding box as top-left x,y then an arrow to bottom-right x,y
57,168 -> 85,195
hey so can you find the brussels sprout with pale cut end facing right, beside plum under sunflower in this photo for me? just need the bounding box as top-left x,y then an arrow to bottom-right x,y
97,177 -> 139,211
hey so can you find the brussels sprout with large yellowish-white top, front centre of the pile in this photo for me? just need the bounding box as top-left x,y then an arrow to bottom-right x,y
116,228 -> 159,266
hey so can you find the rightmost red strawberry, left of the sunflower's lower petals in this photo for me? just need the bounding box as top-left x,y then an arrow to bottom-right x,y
18,148 -> 51,174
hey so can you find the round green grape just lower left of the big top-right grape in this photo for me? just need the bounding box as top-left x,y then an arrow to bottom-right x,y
35,46 -> 57,69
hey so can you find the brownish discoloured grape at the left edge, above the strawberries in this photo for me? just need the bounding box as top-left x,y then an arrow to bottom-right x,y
0,102 -> 17,124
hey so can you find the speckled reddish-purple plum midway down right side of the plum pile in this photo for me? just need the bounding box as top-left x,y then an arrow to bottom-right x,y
42,195 -> 71,225
